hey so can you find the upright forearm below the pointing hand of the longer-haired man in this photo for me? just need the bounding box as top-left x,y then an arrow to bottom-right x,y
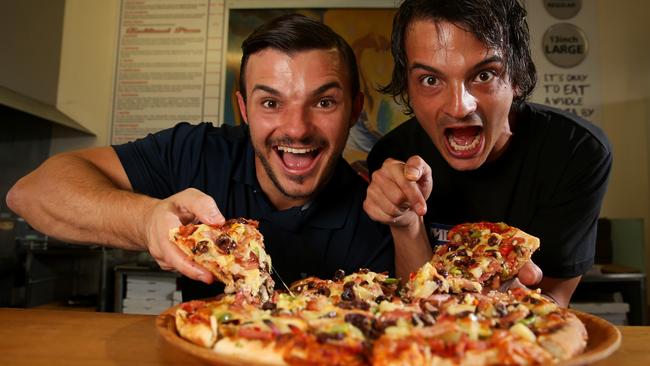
391,217 -> 433,282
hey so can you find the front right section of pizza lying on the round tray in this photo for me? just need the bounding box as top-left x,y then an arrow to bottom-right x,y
372,289 -> 586,365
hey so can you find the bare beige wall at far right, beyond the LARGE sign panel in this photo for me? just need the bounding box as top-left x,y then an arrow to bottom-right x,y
598,0 -> 650,300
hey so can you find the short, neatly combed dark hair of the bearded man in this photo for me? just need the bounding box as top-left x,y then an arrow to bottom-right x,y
239,14 -> 360,100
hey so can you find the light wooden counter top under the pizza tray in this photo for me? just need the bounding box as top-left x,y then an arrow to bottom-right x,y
0,308 -> 650,366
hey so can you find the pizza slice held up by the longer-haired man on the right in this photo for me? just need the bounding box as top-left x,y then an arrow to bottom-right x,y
431,222 -> 539,292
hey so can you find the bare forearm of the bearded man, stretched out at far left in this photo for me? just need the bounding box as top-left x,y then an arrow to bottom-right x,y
7,154 -> 156,250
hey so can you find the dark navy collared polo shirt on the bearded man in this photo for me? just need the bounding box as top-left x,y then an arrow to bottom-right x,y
114,123 -> 394,301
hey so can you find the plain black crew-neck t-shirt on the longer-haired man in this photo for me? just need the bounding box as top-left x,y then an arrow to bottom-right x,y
368,103 -> 612,278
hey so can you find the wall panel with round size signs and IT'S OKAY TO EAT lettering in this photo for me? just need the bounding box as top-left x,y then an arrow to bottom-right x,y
526,0 -> 602,122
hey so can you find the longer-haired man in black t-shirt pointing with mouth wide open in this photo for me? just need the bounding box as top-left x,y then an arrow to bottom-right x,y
364,0 -> 612,306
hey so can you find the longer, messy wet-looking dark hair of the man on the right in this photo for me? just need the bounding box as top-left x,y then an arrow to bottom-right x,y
379,0 -> 537,114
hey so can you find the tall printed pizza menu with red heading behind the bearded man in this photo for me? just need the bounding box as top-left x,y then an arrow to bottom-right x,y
111,0 -> 224,144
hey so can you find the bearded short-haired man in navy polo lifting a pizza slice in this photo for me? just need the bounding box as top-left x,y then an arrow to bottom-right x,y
7,15 -> 394,300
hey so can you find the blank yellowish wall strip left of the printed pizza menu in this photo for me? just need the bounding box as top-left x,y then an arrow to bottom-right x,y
51,0 -> 120,154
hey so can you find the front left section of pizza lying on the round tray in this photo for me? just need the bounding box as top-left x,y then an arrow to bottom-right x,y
175,291 -> 374,366
